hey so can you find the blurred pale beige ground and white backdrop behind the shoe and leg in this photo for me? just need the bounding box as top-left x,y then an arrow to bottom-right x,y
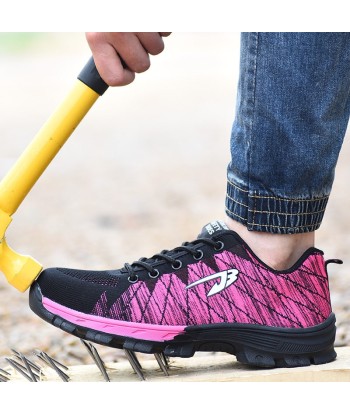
0,33 -> 350,367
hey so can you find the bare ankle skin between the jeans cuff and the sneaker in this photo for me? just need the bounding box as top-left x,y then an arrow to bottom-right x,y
225,217 -> 315,271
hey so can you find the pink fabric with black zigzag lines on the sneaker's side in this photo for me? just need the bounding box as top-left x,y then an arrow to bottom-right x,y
91,251 -> 331,330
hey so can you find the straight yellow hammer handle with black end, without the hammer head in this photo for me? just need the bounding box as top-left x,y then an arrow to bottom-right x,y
0,58 -> 108,216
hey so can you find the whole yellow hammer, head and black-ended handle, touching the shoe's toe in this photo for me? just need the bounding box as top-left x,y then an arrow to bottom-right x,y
0,58 -> 108,292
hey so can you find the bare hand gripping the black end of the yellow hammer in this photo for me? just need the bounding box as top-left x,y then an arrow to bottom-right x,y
86,32 -> 171,86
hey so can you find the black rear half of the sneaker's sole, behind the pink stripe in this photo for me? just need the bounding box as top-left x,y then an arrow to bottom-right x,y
171,313 -> 337,368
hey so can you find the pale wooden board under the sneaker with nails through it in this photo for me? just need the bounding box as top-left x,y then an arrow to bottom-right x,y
7,347 -> 350,382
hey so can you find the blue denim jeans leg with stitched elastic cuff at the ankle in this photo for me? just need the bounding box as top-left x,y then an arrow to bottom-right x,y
226,32 -> 350,234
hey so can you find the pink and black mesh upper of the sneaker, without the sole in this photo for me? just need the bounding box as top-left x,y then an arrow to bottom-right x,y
38,221 -> 331,328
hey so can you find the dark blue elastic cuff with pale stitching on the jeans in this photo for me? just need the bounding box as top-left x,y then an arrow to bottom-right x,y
226,180 -> 329,234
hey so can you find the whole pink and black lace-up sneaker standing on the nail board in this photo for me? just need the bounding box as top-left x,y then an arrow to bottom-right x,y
29,221 -> 341,367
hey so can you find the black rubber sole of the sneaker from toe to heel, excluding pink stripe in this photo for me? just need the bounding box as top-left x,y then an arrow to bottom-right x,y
29,282 -> 337,368
